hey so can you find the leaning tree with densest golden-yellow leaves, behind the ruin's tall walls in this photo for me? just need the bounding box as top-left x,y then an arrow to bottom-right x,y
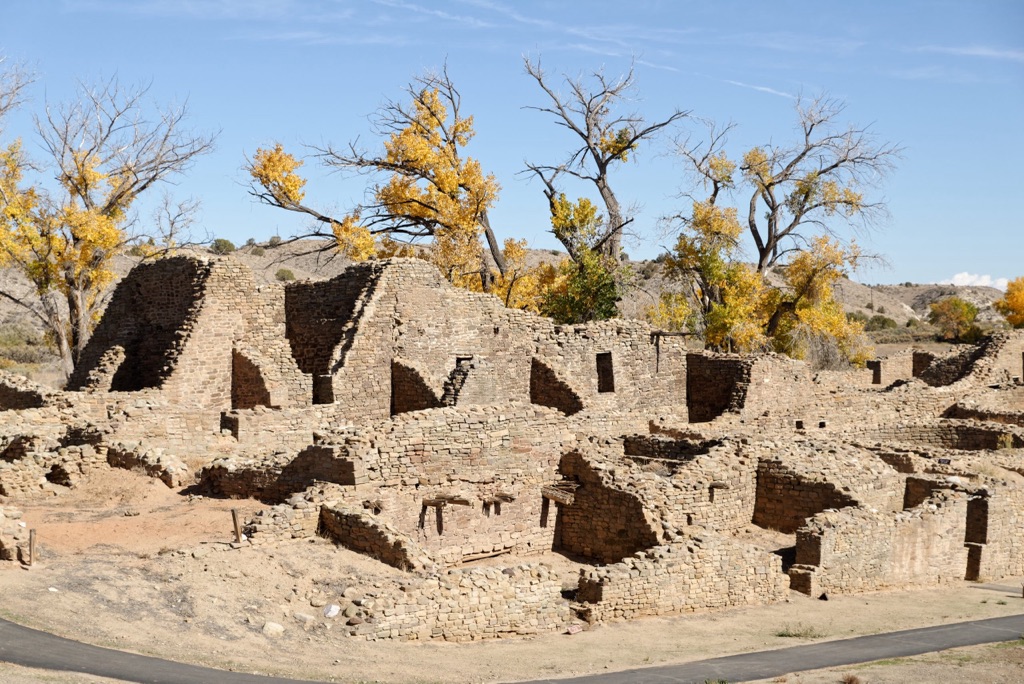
246,64 -> 539,296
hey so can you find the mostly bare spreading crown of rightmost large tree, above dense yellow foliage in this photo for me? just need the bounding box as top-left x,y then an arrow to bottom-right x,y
678,95 -> 902,271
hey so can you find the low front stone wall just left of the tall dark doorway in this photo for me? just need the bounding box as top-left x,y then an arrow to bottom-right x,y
790,490 -> 969,596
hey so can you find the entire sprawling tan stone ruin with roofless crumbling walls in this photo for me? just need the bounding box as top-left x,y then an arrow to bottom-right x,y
6,252 -> 1024,641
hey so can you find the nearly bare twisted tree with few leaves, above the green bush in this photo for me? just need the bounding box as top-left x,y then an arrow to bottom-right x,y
523,57 -> 688,260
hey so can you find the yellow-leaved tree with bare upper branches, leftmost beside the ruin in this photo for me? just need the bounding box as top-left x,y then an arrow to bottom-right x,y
0,68 -> 213,374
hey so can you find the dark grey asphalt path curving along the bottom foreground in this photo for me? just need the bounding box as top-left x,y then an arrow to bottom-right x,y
0,614 -> 1024,684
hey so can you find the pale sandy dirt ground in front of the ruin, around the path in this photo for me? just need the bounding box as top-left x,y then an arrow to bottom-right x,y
0,470 -> 1024,684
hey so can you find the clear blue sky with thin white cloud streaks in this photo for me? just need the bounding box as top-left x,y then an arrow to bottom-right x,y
0,0 -> 1024,283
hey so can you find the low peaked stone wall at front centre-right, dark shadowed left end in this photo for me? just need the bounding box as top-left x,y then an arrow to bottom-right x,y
577,532 -> 790,623
